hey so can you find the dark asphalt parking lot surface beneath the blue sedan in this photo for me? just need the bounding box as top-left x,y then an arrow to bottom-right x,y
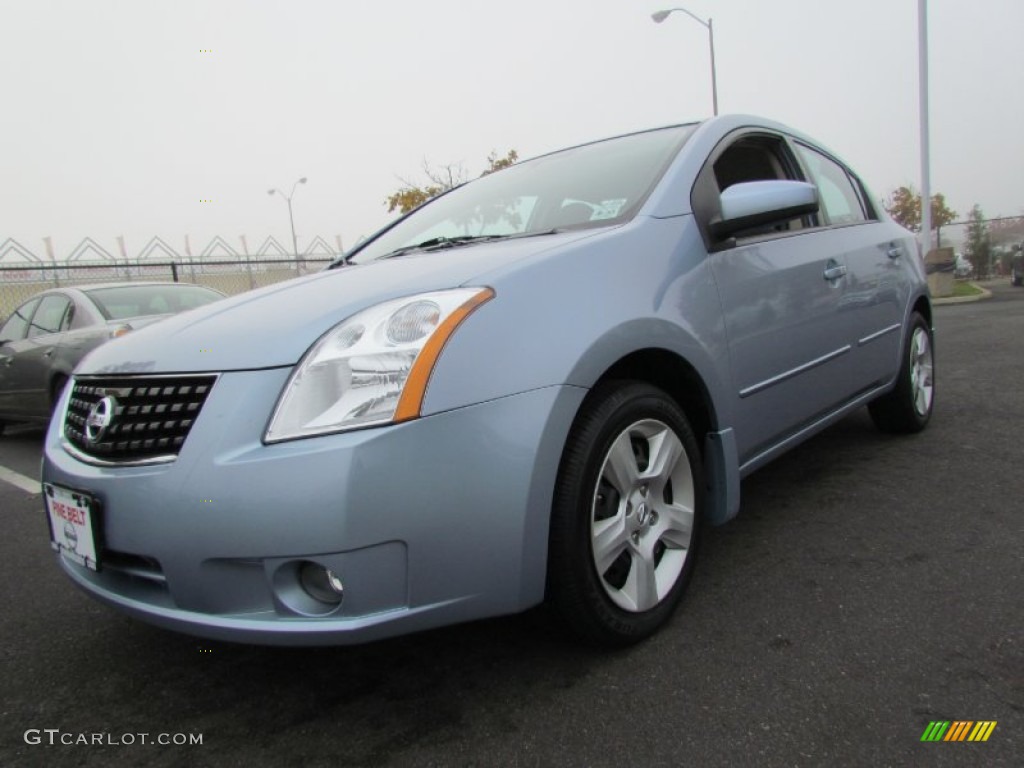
0,282 -> 1024,766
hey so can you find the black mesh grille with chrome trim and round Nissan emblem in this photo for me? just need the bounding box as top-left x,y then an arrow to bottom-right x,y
63,375 -> 217,464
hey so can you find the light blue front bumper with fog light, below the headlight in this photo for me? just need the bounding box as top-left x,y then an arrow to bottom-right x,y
43,369 -> 586,645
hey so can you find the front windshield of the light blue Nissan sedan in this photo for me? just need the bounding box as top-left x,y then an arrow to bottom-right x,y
348,125 -> 695,263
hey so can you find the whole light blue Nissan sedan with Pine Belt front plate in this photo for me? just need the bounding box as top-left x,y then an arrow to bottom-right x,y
43,116 -> 934,645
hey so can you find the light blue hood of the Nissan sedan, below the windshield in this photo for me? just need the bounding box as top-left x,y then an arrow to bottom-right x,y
76,229 -> 596,375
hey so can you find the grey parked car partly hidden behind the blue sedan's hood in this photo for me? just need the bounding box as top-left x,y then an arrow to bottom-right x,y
0,283 -> 223,433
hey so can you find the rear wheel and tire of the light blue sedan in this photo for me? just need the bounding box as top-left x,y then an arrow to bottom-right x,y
867,312 -> 935,433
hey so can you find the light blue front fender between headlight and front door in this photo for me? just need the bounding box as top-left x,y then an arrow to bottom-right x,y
423,216 -> 731,421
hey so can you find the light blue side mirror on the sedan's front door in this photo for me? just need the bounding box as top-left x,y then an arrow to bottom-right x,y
711,180 -> 818,240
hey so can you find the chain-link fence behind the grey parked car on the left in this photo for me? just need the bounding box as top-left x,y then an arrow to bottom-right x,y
0,256 -> 332,321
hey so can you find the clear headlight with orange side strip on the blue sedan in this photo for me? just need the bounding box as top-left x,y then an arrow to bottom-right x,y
263,288 -> 495,442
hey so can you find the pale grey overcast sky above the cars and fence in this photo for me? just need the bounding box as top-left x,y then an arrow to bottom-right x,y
0,0 -> 1024,261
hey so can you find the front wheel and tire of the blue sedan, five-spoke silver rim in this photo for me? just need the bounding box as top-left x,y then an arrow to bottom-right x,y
548,381 -> 705,646
